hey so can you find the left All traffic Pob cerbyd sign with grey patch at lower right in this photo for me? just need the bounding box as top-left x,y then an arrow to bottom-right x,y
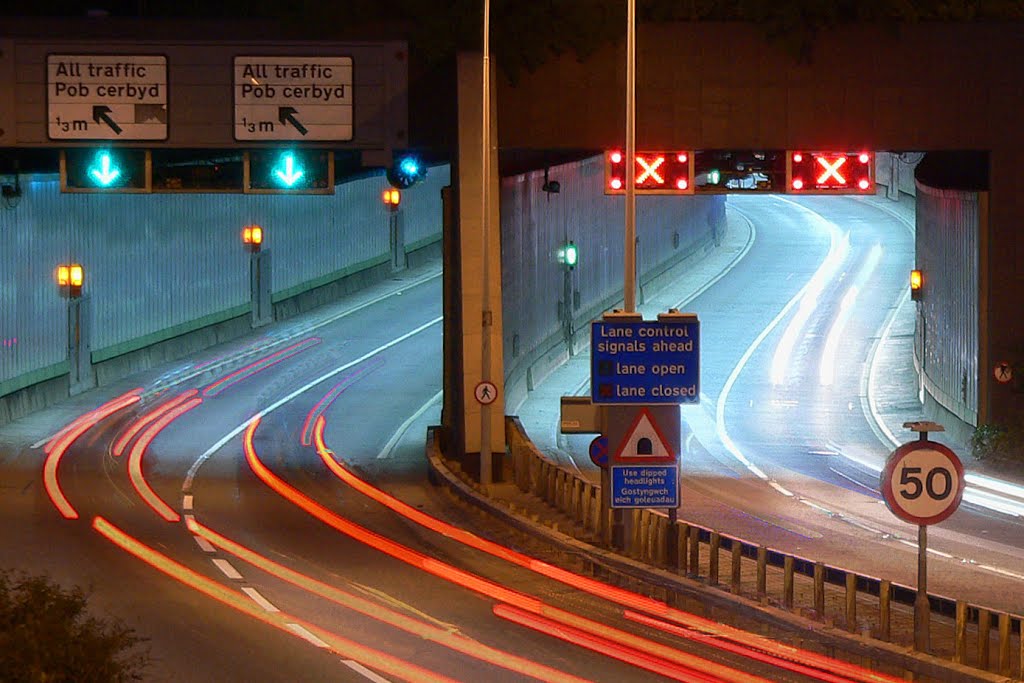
46,54 -> 167,140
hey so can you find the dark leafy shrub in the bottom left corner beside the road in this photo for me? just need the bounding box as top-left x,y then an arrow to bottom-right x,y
0,570 -> 150,683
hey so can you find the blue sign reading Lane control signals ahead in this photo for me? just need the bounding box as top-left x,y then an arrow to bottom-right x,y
590,317 -> 700,403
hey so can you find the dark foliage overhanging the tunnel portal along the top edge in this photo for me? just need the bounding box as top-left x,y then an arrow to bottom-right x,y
0,0 -> 1024,77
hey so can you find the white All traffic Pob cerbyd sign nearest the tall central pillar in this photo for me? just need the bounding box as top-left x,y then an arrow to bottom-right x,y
234,56 -> 352,140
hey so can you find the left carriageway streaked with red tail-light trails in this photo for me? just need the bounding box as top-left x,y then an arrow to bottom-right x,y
0,259 -> 888,682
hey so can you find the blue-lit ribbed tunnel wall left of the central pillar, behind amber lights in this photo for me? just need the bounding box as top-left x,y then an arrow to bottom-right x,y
0,165 -> 450,424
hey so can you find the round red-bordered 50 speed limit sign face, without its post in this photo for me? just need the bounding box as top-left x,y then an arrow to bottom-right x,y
880,441 -> 965,525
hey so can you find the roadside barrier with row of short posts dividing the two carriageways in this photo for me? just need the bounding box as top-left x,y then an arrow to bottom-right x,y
506,417 -> 1024,679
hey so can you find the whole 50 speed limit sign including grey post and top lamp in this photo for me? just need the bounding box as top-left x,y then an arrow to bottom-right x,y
880,422 -> 966,652
